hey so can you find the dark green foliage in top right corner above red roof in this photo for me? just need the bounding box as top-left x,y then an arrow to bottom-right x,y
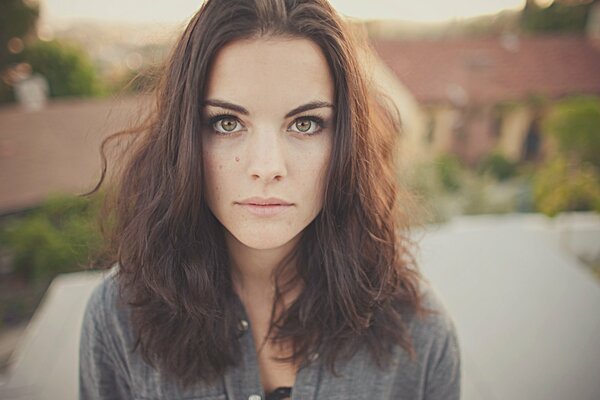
520,0 -> 594,32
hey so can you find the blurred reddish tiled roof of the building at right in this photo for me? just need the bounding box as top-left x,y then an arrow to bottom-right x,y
373,35 -> 600,103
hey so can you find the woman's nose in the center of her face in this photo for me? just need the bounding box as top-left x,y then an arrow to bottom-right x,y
248,130 -> 287,183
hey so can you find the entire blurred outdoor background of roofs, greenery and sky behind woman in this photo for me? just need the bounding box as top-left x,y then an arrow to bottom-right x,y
0,0 -> 600,399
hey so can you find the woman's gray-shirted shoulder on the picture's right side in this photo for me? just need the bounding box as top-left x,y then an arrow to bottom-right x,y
319,284 -> 461,400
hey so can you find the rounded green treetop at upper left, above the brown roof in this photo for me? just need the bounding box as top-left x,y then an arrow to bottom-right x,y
20,40 -> 101,97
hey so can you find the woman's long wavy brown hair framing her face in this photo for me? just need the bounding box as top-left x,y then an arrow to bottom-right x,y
90,0 -> 429,386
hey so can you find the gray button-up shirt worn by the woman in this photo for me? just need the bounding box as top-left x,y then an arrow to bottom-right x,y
79,273 -> 461,400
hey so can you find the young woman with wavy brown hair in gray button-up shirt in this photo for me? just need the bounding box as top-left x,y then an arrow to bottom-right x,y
80,0 -> 460,400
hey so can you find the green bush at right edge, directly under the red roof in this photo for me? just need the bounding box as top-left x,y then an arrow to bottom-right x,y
543,97 -> 600,169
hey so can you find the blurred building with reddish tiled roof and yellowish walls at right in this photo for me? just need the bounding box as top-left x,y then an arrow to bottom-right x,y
373,25 -> 600,164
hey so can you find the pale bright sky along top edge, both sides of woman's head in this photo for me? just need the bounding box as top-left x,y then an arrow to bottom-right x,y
40,0 -> 525,23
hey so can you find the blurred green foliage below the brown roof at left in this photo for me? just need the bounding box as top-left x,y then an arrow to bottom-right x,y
0,195 -> 102,282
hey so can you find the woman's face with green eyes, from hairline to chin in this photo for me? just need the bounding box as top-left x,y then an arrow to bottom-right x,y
202,37 -> 334,249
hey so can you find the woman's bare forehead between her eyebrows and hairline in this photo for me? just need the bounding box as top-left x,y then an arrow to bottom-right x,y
205,37 -> 333,112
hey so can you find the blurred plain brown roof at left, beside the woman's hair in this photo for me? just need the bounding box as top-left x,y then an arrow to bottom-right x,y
0,96 -> 147,214
